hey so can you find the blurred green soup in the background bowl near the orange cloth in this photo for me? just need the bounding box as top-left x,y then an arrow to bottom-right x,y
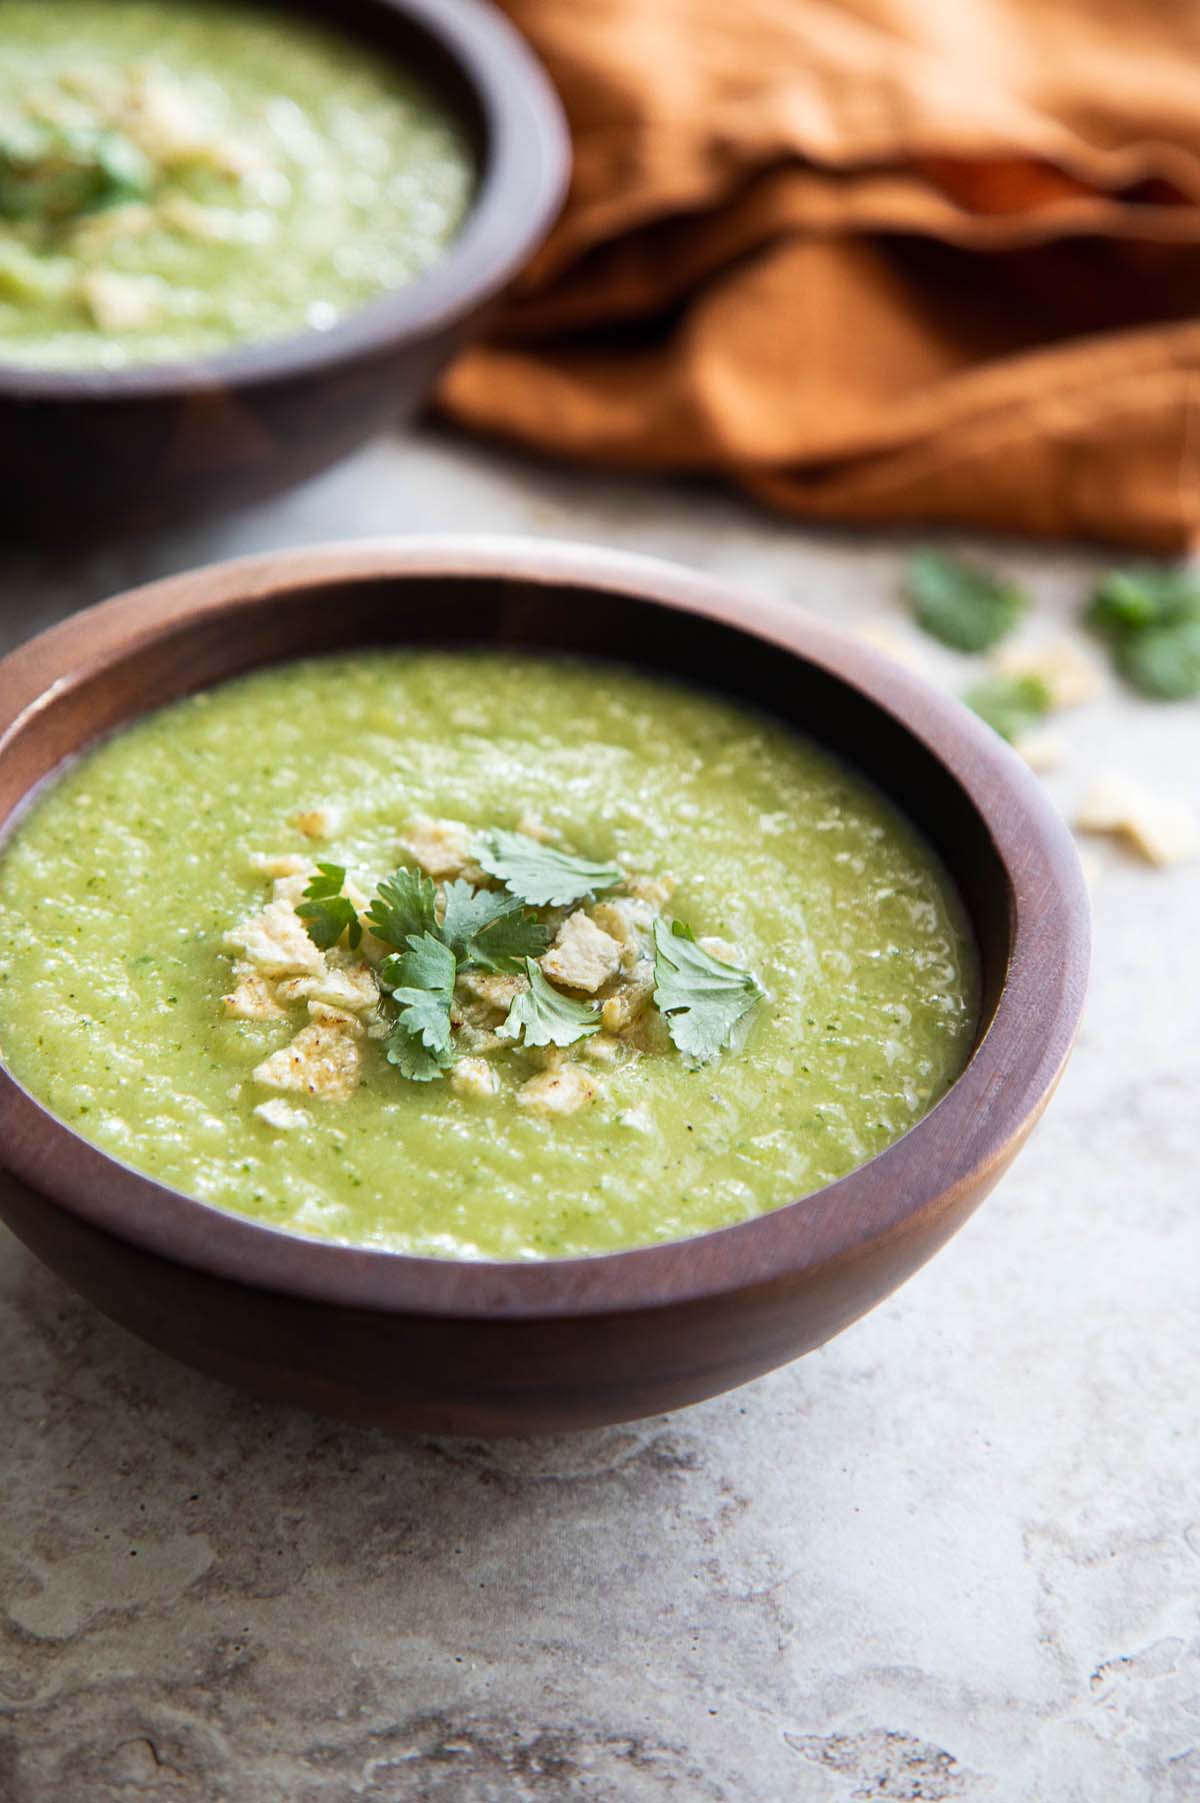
0,0 -> 474,368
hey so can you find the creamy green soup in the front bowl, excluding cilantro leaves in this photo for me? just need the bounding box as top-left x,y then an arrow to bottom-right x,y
0,651 -> 977,1258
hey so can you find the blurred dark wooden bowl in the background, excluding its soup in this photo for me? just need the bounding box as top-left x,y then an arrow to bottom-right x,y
0,0 -> 569,543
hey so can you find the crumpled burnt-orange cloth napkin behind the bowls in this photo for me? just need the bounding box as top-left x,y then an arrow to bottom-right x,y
441,0 -> 1200,548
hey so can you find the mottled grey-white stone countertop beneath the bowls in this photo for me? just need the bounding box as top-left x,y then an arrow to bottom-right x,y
0,435 -> 1200,1803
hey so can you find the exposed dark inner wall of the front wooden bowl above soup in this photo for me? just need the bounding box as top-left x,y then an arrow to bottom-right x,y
0,573 -> 1013,1037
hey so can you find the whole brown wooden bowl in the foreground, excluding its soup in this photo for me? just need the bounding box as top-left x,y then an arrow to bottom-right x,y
0,539 -> 1088,1435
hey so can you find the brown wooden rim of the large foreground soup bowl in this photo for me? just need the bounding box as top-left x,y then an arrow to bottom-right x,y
0,535 -> 1088,1320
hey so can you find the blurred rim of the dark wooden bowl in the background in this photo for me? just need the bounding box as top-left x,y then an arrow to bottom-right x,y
0,0 -> 571,402
